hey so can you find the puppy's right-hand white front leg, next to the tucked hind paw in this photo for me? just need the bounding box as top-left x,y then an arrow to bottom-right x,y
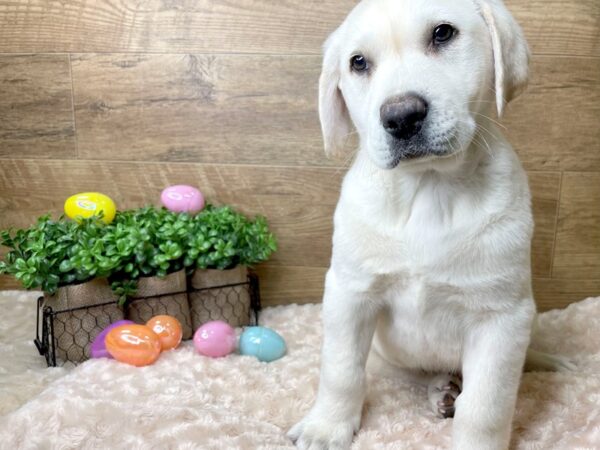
452,307 -> 533,450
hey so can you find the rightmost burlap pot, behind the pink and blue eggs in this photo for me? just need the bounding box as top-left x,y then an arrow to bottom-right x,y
189,266 -> 251,330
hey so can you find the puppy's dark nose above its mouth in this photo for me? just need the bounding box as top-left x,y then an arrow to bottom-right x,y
379,94 -> 428,139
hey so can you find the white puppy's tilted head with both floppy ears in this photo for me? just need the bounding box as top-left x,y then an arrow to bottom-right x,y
319,0 -> 529,169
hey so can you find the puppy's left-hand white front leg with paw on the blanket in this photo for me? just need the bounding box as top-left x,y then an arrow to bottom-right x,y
288,269 -> 376,450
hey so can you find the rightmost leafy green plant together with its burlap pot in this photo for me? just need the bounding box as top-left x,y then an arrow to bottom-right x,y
184,205 -> 277,329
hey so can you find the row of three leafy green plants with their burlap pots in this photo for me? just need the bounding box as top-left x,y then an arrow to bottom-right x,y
0,205 -> 276,362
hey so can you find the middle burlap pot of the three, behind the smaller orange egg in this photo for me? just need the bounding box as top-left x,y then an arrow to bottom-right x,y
126,270 -> 193,339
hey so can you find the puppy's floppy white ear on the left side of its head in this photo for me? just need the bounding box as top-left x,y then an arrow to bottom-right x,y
319,32 -> 352,156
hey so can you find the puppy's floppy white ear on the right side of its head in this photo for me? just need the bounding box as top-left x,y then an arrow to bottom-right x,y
477,0 -> 529,116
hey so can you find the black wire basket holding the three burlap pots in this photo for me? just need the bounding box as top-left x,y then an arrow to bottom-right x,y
34,273 -> 261,367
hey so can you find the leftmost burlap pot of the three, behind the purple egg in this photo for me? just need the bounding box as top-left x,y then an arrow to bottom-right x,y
44,278 -> 124,365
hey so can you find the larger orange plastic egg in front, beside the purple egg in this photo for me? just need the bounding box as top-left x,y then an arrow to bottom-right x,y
105,324 -> 161,366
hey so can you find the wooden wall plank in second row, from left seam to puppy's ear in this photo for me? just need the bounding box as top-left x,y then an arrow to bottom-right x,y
72,54 -> 328,165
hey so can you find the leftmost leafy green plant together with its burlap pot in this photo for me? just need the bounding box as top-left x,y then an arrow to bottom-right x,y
0,215 -> 124,362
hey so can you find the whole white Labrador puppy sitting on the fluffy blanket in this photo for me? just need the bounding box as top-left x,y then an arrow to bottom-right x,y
289,0 -> 569,450
